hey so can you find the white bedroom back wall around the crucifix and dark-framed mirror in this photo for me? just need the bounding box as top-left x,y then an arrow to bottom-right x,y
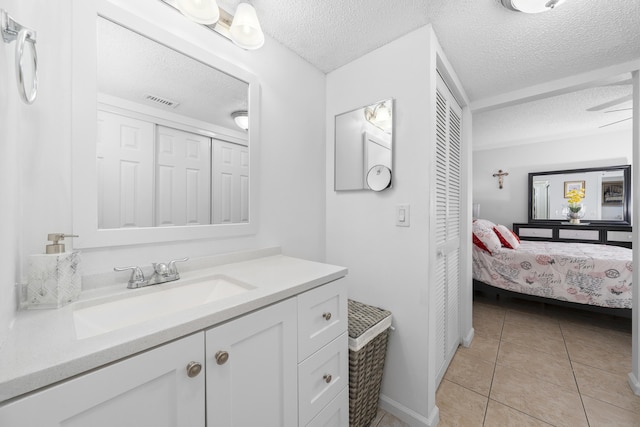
473,130 -> 632,227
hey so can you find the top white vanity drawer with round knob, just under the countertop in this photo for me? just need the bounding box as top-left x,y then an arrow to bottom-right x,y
298,280 -> 348,362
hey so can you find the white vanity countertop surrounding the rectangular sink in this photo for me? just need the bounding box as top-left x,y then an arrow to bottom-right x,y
0,251 -> 347,402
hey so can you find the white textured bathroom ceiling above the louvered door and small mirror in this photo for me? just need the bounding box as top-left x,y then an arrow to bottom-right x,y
236,0 -> 640,101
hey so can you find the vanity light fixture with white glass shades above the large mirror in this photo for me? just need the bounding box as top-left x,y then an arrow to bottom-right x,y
168,0 -> 264,50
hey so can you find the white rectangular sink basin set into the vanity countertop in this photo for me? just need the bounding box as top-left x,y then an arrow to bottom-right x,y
73,275 -> 253,339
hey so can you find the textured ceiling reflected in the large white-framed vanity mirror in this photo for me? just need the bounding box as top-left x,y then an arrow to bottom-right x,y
98,18 -> 248,131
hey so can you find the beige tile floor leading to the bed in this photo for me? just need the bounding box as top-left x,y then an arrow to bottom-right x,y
440,298 -> 640,427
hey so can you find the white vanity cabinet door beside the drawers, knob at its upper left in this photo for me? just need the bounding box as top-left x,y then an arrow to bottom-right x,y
206,299 -> 298,427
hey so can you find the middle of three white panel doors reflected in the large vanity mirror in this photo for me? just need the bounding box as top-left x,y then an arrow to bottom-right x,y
156,126 -> 211,226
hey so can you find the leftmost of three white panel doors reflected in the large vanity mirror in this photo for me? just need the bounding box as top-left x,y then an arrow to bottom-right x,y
96,111 -> 154,228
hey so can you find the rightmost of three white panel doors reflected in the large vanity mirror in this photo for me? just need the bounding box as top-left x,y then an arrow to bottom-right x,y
211,139 -> 249,224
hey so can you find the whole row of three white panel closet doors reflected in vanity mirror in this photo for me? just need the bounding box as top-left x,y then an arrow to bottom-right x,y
97,110 -> 249,229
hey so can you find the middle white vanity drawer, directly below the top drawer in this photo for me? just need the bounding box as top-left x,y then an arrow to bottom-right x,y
298,332 -> 349,426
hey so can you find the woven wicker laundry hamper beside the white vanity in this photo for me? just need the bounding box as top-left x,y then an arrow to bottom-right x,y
349,300 -> 391,427
